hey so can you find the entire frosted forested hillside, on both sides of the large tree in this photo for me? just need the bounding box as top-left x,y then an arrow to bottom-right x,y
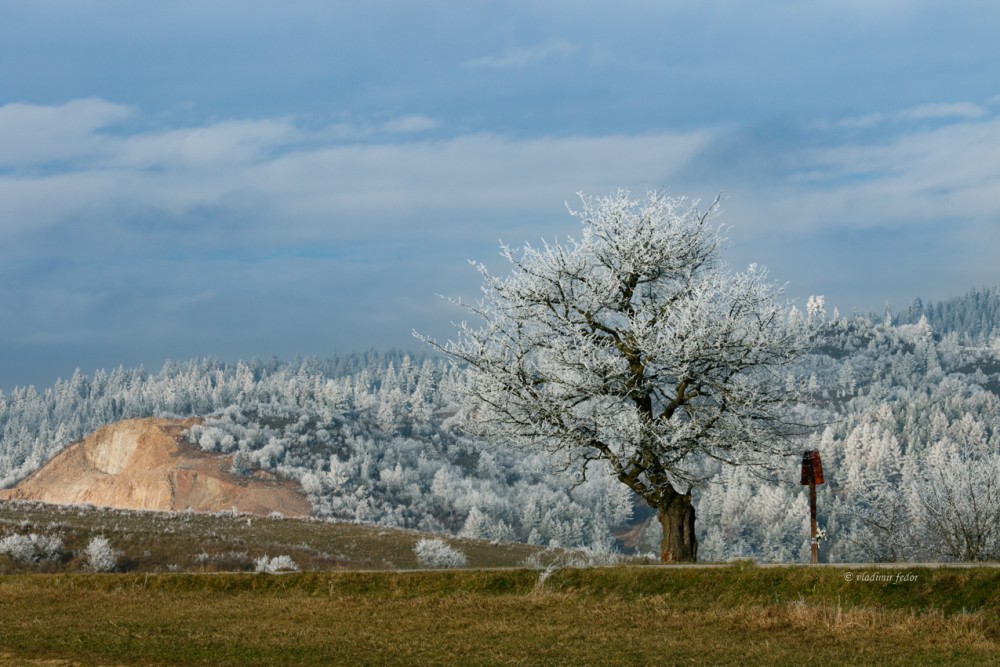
0,288 -> 1000,561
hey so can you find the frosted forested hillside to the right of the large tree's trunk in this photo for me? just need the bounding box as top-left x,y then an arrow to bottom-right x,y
699,301 -> 1000,561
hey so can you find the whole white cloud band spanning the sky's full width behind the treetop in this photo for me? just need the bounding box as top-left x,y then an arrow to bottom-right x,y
0,96 -> 1000,284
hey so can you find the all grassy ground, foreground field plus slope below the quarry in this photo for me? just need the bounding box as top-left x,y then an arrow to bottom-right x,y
0,503 -> 1000,667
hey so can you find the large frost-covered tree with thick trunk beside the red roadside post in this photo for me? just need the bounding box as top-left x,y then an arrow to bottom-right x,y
425,191 -> 807,561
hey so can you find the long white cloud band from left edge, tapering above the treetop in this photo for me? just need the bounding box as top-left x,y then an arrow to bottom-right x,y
0,99 -> 710,245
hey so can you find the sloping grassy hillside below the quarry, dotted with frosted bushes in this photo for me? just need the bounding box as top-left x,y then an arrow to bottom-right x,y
0,501 -> 558,574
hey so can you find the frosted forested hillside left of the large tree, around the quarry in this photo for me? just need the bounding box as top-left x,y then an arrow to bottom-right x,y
0,353 -> 632,549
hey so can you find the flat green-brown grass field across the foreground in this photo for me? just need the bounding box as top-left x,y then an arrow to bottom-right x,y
0,566 -> 1000,666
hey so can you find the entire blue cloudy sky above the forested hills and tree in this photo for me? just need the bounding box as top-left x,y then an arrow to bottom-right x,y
0,0 -> 1000,391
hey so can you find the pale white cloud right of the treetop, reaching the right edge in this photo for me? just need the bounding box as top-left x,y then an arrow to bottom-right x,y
729,113 -> 1000,252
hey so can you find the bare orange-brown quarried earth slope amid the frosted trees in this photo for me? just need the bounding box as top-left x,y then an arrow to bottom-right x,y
0,419 -> 311,516
